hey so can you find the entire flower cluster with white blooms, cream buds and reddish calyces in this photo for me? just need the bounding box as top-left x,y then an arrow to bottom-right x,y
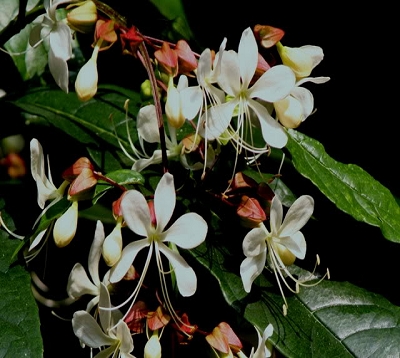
0,0 -> 329,358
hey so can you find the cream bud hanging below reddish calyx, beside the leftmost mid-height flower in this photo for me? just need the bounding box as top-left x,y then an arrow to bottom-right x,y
53,201 -> 78,247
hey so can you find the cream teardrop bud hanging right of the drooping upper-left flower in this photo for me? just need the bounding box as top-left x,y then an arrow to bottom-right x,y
75,56 -> 98,101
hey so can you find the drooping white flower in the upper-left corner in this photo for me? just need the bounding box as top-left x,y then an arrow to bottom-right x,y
29,0 -> 72,93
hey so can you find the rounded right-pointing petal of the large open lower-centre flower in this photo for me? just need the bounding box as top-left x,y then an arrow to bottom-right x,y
162,213 -> 208,249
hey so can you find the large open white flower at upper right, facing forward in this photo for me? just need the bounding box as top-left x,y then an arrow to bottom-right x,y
200,28 -> 295,150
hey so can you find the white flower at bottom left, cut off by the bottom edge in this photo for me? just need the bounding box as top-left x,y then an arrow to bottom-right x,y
72,284 -> 134,358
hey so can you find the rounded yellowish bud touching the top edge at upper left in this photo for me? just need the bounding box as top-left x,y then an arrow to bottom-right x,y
67,1 -> 97,33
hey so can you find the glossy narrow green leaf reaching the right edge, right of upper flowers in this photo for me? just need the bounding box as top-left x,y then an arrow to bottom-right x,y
287,130 -> 400,242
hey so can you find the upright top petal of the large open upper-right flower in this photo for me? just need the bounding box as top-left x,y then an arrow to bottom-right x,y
238,27 -> 258,88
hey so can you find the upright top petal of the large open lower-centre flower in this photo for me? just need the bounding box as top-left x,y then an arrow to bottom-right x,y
154,173 -> 176,233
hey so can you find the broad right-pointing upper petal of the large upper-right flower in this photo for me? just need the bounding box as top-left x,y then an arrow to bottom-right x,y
248,65 -> 296,102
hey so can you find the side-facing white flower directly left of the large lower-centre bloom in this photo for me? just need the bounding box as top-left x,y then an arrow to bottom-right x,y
67,220 -> 109,312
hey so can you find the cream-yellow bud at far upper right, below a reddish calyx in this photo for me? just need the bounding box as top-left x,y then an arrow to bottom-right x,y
276,42 -> 324,78
